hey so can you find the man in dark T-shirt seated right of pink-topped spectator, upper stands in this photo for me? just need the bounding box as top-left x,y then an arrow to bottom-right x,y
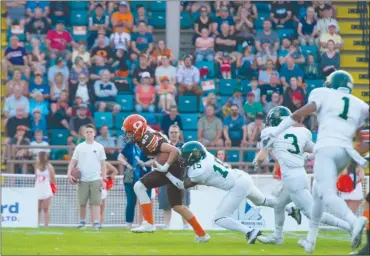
215,23 -> 240,60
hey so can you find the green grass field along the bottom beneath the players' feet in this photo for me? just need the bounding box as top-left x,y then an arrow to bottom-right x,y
1,228 -> 358,255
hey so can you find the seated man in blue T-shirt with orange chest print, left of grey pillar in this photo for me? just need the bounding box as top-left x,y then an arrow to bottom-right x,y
131,21 -> 153,59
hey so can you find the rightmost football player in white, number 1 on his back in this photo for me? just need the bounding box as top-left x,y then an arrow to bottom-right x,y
270,70 -> 369,252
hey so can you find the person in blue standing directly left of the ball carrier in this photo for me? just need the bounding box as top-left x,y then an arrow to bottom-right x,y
118,142 -> 151,229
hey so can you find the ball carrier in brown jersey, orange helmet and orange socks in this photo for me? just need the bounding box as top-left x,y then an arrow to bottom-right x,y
122,114 -> 211,243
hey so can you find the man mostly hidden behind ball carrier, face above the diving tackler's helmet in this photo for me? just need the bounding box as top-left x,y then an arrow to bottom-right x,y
158,124 -> 190,229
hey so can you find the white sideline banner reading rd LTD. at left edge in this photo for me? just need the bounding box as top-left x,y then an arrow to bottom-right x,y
1,188 -> 38,228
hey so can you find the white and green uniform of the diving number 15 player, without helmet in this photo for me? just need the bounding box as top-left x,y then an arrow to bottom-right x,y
188,152 -> 276,226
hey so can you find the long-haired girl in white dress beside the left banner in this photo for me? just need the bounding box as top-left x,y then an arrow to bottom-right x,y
35,151 -> 55,227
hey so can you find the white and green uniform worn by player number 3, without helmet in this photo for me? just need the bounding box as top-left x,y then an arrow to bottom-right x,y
261,127 -> 350,237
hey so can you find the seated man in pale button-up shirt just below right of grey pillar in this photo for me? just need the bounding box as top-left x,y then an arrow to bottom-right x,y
177,55 -> 203,96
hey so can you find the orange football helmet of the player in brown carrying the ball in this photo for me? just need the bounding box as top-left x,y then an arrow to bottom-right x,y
121,114 -> 148,142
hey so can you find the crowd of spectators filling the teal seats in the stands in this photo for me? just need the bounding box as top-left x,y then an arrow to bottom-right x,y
2,0 -> 343,173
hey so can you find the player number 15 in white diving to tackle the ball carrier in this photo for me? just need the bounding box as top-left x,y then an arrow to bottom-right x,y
160,141 -> 298,244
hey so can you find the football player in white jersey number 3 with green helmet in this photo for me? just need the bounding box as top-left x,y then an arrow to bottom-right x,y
254,106 -> 351,244
